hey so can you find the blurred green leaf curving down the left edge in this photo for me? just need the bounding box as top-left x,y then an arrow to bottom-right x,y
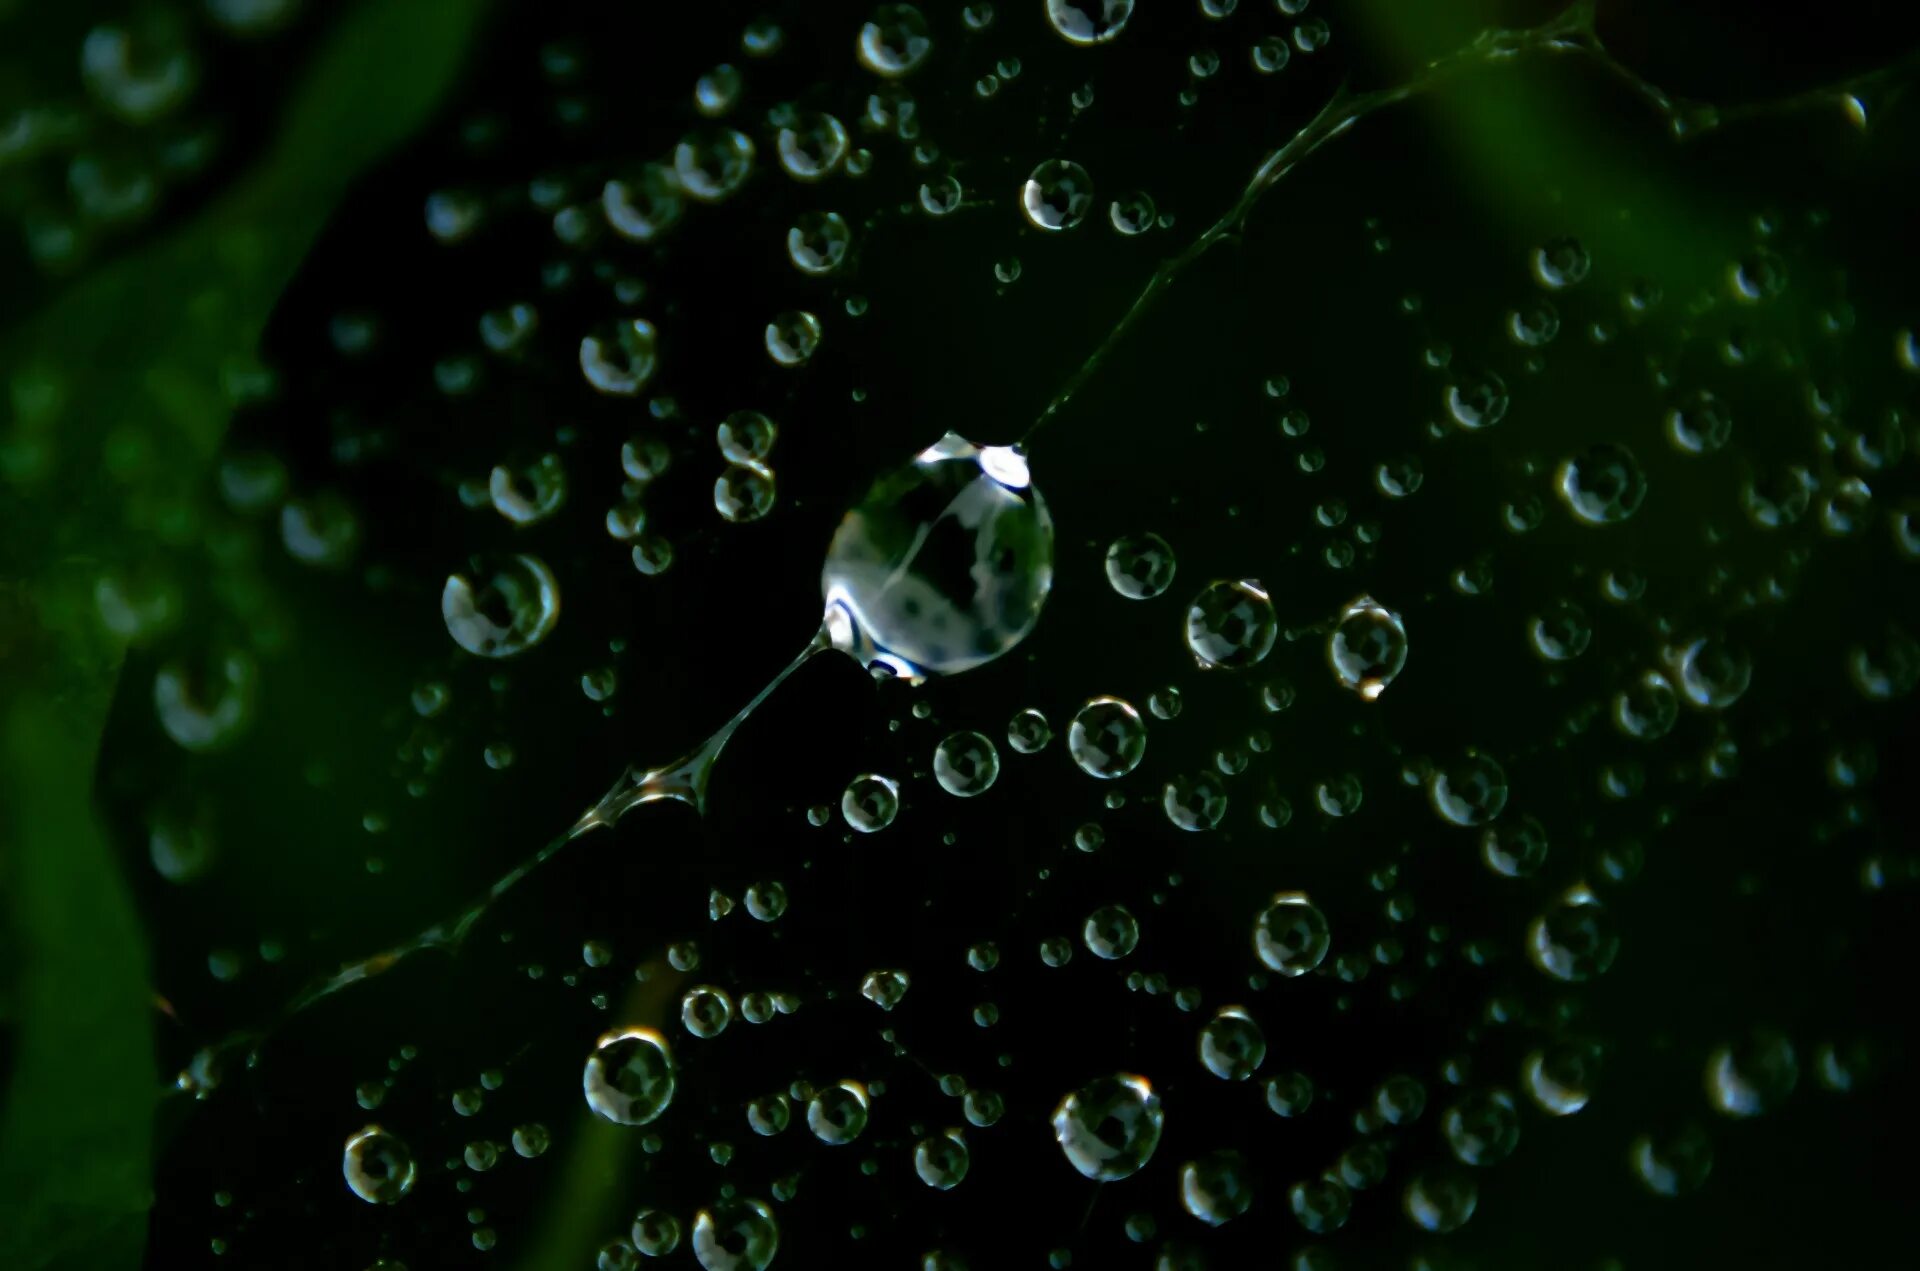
0,0 -> 488,1271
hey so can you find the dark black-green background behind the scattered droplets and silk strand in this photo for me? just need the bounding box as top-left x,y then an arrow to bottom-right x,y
8,0 -> 1920,1271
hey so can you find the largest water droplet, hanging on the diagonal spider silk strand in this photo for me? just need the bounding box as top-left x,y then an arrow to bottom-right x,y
820,432 -> 1054,678
